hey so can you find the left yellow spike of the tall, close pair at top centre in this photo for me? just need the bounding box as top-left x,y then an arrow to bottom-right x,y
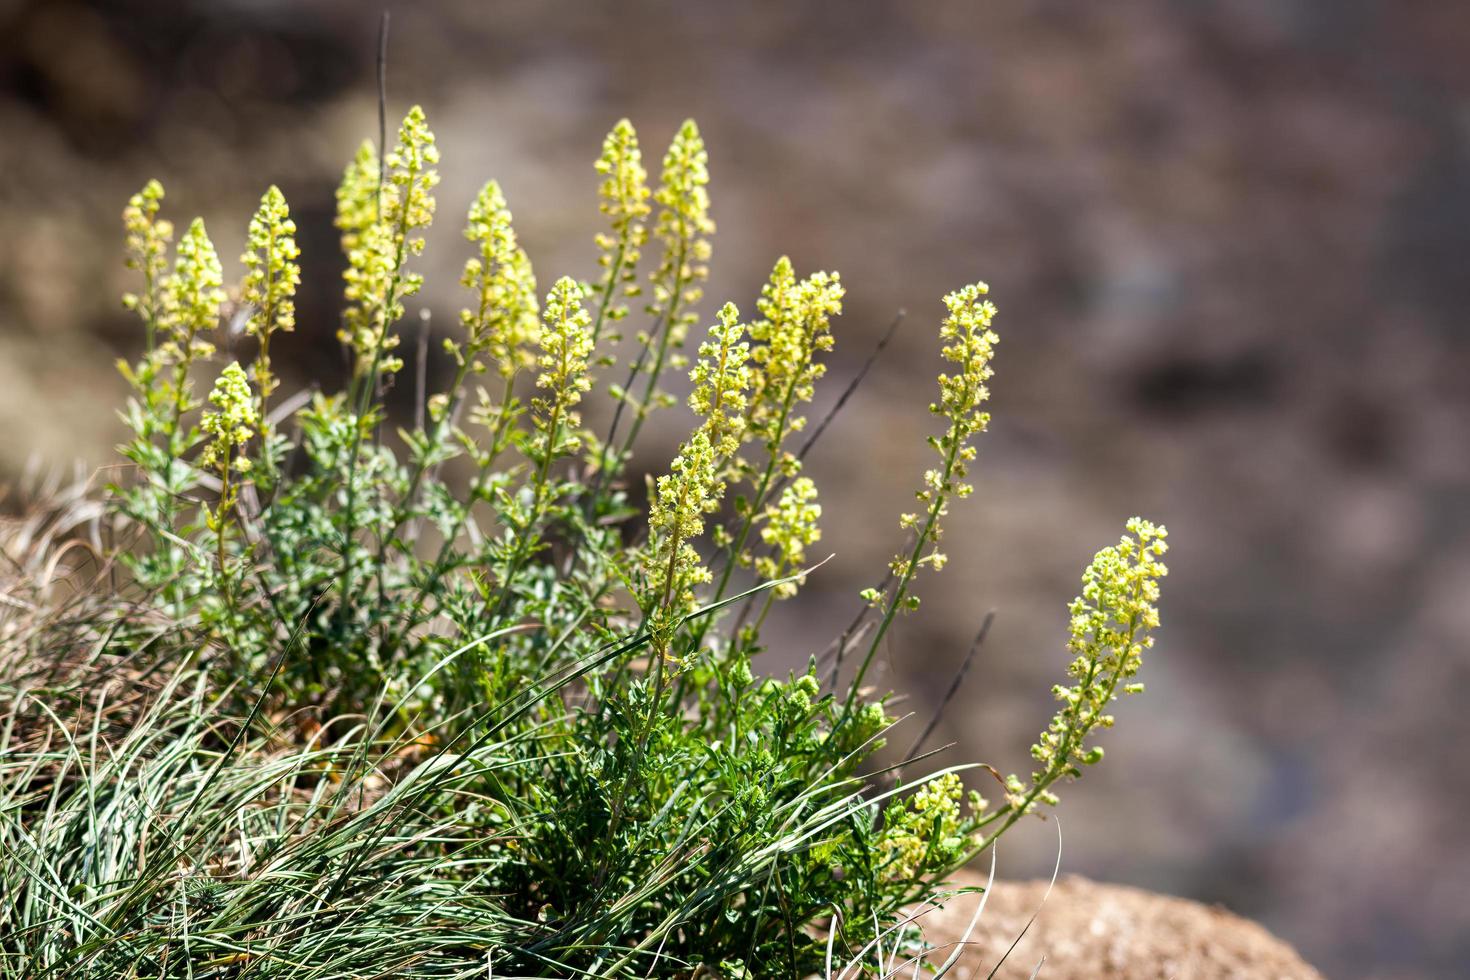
594,119 -> 653,322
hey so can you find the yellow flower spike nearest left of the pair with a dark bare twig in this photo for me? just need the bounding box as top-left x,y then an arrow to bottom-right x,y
240,185 -> 301,405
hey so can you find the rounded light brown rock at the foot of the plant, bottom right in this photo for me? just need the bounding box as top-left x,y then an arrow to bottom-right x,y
923,876 -> 1322,980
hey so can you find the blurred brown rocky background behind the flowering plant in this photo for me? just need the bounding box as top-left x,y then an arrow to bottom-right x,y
0,0 -> 1470,979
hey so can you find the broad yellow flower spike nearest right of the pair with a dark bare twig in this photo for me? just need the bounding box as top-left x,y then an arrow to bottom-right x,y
458,181 -> 541,379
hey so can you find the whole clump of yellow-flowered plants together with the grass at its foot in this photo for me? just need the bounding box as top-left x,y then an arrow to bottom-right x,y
0,109 -> 1164,979
